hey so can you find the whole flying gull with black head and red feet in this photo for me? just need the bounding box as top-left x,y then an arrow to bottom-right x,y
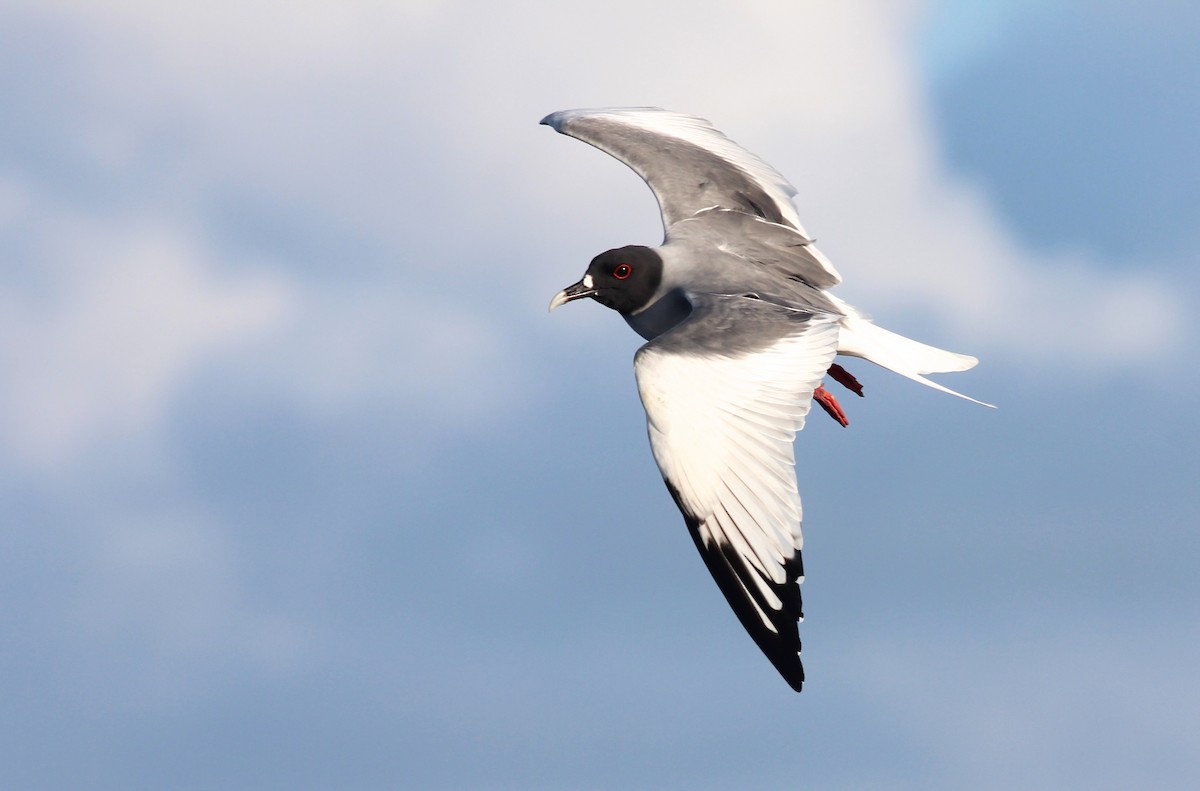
541,107 -> 990,691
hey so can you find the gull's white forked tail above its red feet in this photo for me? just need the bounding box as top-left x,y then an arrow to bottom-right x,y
838,313 -> 992,407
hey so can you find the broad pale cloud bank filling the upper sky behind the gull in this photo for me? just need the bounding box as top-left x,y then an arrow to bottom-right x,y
0,1 -> 1188,463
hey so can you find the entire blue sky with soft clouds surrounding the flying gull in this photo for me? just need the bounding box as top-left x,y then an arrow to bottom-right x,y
0,0 -> 1200,790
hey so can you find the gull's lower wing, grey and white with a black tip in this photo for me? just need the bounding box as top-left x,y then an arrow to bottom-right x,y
635,296 -> 838,691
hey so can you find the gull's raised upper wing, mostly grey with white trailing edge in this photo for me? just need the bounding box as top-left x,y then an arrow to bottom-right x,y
541,107 -> 804,234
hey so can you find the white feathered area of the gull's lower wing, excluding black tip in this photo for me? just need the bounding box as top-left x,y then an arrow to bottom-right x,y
635,320 -> 838,634
